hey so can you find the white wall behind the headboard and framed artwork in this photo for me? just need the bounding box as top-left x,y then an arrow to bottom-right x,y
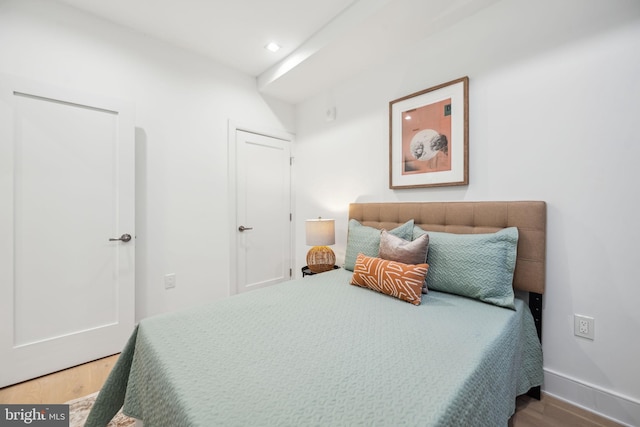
295,0 -> 640,425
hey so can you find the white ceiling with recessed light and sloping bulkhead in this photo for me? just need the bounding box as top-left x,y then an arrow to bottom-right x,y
53,0 -> 498,104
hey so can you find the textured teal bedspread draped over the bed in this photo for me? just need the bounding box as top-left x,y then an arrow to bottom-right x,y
86,269 -> 542,427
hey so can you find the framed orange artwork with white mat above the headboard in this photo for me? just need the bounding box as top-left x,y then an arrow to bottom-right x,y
389,77 -> 469,189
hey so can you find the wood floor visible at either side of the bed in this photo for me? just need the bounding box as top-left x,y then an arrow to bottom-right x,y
0,355 -> 619,427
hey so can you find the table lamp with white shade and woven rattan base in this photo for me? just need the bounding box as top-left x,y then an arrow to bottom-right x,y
305,217 -> 336,273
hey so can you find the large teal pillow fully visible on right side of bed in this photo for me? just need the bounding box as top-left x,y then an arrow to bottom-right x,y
417,227 -> 518,309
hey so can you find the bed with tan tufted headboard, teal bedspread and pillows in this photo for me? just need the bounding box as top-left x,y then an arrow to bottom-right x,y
86,201 -> 546,427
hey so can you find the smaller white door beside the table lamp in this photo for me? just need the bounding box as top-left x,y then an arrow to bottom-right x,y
234,130 -> 292,292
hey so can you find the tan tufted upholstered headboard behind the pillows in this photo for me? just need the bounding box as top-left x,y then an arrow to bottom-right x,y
349,201 -> 547,294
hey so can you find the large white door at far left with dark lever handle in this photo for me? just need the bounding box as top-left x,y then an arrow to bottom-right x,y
0,76 -> 135,387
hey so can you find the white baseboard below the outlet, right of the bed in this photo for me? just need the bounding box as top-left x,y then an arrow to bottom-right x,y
542,369 -> 640,427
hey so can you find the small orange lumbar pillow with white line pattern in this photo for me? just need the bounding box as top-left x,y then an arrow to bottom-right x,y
351,254 -> 429,305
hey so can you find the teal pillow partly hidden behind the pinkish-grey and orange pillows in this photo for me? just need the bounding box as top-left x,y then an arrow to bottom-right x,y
344,219 -> 413,271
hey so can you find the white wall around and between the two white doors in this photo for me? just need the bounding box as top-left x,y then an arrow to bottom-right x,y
0,0 -> 294,319
